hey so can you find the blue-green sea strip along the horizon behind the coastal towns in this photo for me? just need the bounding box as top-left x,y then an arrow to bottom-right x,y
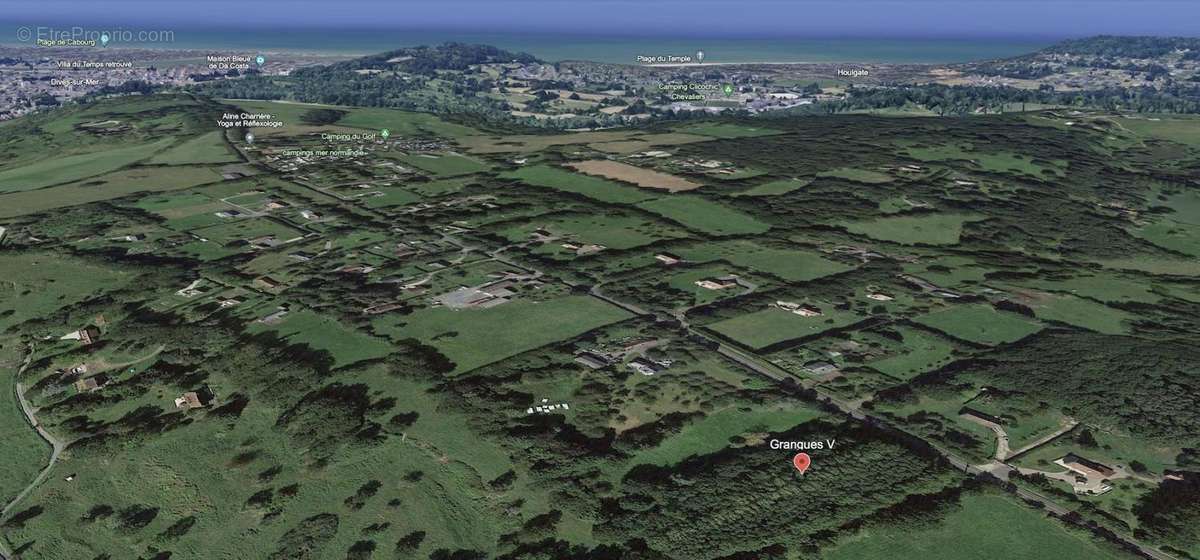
0,22 -> 1054,64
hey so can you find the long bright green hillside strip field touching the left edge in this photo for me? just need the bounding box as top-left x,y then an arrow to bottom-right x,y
0,138 -> 175,193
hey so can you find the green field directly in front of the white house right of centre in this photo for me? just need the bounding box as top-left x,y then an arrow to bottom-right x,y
708,307 -> 860,350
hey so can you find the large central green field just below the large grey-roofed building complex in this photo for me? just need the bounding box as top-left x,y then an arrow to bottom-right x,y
374,296 -> 630,372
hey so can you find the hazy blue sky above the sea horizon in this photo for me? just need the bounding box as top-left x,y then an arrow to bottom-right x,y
7,0 -> 1200,38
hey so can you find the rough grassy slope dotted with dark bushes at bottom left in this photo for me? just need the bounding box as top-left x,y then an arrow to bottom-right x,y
3,390 -> 508,559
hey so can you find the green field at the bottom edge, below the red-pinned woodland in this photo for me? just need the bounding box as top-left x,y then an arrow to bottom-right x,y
821,494 -> 1133,560
